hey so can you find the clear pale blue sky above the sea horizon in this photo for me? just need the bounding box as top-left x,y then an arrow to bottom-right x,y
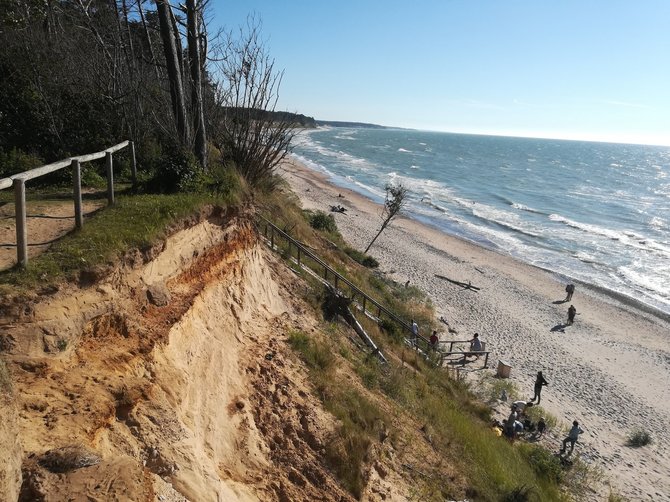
211,0 -> 670,145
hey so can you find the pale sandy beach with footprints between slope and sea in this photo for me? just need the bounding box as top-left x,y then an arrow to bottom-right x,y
279,160 -> 670,500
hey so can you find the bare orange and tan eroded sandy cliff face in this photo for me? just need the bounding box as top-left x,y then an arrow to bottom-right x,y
0,213 -> 362,502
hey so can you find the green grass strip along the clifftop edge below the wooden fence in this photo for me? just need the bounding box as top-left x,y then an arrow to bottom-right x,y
0,194 -> 214,289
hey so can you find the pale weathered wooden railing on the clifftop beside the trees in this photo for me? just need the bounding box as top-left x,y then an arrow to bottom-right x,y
0,141 -> 137,267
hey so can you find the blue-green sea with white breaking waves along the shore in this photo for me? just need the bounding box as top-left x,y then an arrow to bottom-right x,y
293,127 -> 670,314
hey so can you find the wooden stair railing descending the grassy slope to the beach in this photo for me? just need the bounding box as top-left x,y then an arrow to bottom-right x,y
259,218 -> 489,368
